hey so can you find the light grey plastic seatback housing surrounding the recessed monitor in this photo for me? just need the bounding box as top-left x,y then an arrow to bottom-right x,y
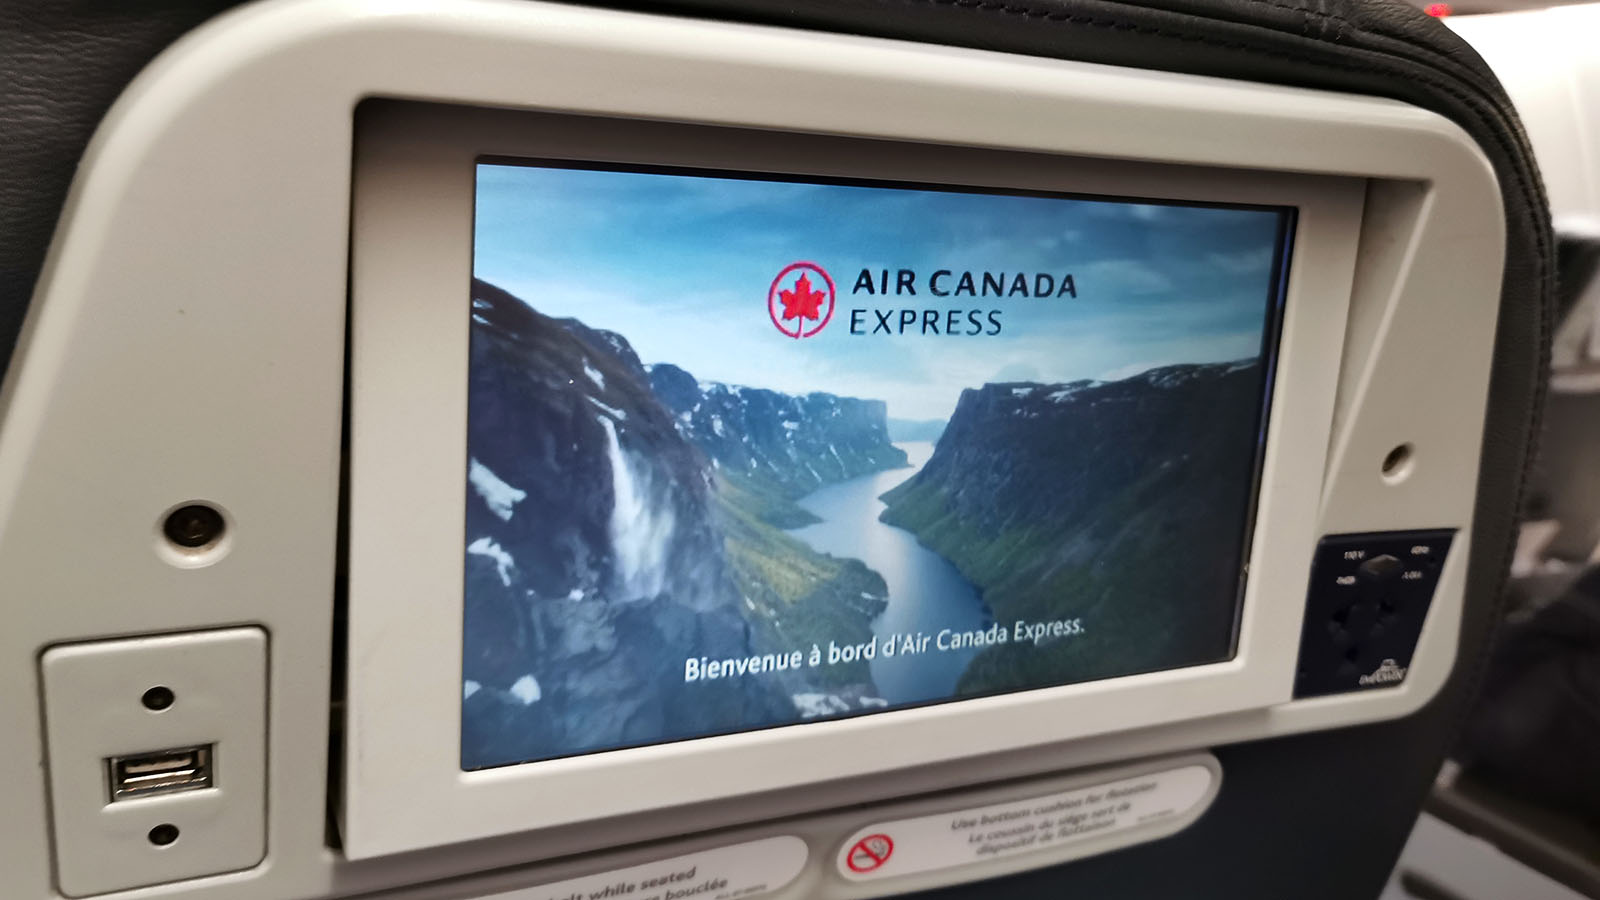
0,0 -> 1504,900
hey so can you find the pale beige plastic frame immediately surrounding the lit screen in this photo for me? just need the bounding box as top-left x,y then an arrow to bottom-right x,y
346,99 -> 1363,839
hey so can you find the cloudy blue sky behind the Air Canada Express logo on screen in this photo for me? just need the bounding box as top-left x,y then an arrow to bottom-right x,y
474,165 -> 1277,420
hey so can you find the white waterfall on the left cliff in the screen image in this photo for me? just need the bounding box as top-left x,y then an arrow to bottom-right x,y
595,416 -> 675,601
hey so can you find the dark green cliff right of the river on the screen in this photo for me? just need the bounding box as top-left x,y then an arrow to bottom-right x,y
882,360 -> 1262,693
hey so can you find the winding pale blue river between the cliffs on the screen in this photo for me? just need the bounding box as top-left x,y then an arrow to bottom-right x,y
789,440 -> 992,705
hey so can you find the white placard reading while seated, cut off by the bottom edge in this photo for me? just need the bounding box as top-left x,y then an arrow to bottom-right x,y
478,834 -> 808,900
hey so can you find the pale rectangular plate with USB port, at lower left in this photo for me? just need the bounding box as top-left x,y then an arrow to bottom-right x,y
40,628 -> 267,897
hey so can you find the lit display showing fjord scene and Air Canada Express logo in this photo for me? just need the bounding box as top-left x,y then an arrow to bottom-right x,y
461,160 -> 1293,769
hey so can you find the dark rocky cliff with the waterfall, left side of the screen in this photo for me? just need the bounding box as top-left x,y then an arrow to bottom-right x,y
462,280 -> 886,759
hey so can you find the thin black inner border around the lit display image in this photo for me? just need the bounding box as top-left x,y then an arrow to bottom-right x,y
462,154 -> 1296,762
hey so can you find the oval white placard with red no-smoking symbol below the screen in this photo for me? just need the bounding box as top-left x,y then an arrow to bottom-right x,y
838,765 -> 1213,881
